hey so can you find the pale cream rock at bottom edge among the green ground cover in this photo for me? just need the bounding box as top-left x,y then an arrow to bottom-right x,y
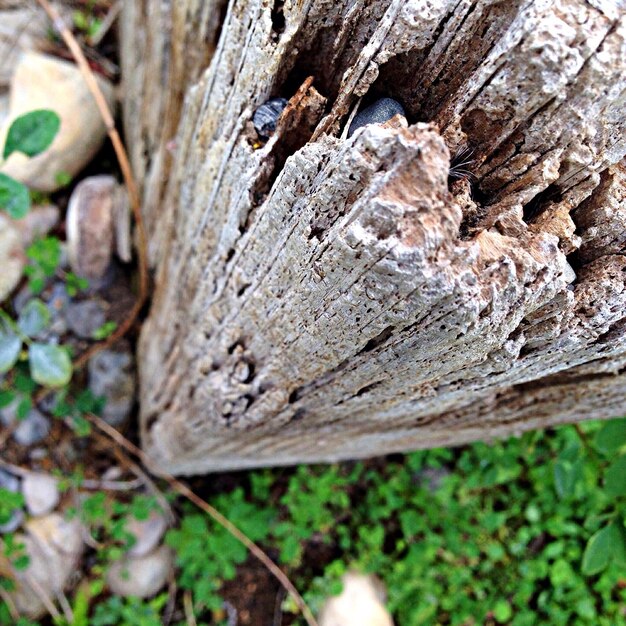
319,572 -> 393,626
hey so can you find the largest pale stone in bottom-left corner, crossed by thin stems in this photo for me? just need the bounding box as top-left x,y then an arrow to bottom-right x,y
10,513 -> 83,619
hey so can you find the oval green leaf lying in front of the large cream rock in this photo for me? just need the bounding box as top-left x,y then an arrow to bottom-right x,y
3,109 -> 61,159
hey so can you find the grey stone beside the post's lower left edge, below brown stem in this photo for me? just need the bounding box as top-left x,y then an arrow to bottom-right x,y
88,350 -> 135,426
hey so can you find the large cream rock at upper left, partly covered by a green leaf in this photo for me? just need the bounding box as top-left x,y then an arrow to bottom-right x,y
0,52 -> 114,192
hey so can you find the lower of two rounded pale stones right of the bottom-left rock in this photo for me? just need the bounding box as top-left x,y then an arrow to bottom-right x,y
106,546 -> 173,598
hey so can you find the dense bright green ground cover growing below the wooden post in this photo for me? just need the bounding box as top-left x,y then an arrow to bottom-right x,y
0,420 -> 626,626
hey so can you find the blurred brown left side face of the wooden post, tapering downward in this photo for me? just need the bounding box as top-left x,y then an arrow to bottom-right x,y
119,0 -> 227,263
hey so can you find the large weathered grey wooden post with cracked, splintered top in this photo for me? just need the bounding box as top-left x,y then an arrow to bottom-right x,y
122,0 -> 626,473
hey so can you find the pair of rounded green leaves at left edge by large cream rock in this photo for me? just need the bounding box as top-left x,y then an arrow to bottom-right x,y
0,109 -> 61,219
